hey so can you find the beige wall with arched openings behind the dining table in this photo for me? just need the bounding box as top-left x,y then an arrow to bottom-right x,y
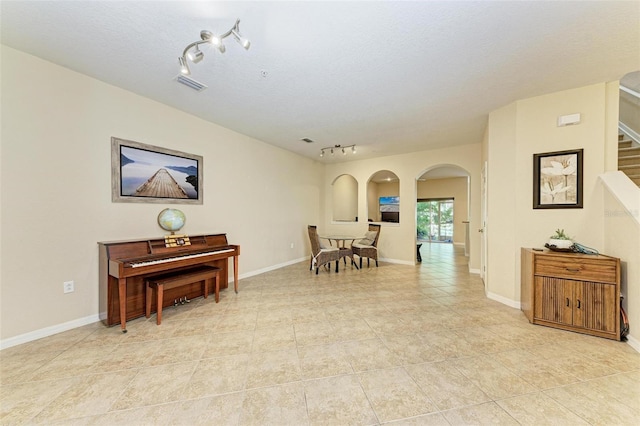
323,141 -> 481,272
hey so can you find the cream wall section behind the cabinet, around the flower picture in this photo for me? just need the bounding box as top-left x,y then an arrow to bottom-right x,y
487,83 -> 612,306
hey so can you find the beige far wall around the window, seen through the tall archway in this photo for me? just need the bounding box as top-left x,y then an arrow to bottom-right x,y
418,177 -> 469,244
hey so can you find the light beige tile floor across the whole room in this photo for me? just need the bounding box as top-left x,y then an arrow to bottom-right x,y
0,244 -> 640,425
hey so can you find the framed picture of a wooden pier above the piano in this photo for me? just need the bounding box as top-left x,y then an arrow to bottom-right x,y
111,137 -> 203,204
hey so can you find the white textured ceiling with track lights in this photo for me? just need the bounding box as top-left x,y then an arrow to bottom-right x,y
0,0 -> 640,162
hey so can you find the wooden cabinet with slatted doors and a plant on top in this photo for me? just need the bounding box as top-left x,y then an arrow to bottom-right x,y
520,248 -> 620,340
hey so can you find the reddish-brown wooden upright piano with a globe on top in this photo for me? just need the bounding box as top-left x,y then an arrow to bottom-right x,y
98,234 -> 240,332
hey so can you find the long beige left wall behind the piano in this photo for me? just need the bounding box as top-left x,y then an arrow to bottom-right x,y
0,46 -> 329,340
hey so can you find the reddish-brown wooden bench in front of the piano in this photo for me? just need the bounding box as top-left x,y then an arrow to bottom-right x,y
145,266 -> 220,325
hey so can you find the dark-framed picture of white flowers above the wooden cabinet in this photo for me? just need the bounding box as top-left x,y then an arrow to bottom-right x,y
533,149 -> 584,209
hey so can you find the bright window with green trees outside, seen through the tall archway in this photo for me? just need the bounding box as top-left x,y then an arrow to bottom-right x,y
417,198 -> 453,243
